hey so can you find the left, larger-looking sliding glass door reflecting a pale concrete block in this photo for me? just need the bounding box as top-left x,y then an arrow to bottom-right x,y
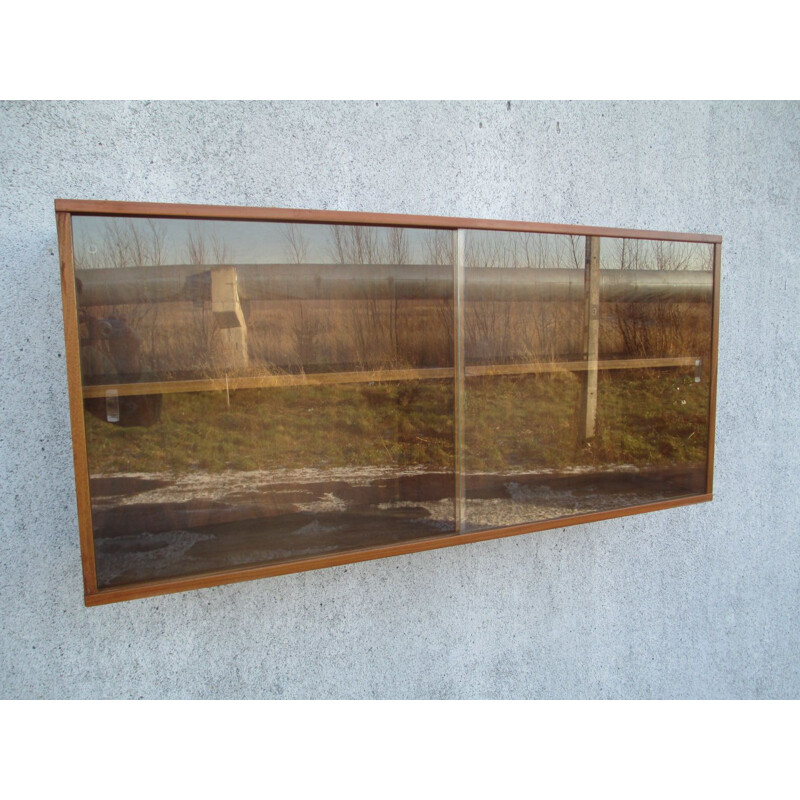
73,216 -> 455,588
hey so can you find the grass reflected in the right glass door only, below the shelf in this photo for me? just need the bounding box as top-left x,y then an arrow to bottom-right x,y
465,370 -> 708,472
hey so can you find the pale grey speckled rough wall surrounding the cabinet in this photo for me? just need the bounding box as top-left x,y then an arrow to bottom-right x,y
0,102 -> 800,698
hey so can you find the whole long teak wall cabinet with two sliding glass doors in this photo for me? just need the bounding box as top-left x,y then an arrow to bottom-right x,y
56,200 -> 721,604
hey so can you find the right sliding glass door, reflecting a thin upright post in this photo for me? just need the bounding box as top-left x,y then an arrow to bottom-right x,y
464,231 -> 713,530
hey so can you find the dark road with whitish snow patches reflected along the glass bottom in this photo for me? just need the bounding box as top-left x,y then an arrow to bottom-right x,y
92,465 -> 704,586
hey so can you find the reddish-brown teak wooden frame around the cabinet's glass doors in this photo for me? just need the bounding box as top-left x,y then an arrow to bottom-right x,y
55,200 -> 722,606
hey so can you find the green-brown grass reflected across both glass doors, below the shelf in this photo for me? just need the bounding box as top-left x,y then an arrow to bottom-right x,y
85,369 -> 708,482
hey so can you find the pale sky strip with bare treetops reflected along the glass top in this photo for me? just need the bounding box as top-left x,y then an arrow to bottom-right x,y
73,216 -> 713,271
